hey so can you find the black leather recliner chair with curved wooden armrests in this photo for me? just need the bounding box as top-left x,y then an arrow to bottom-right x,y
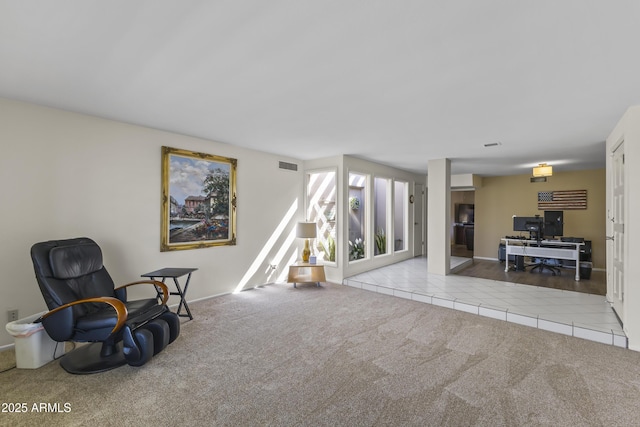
31,237 -> 180,374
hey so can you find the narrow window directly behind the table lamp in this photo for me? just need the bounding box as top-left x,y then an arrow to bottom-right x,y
307,171 -> 336,263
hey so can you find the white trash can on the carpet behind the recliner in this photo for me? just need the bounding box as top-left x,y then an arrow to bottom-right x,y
5,311 -> 64,369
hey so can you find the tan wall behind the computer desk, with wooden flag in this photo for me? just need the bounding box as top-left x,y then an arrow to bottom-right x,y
474,169 -> 606,269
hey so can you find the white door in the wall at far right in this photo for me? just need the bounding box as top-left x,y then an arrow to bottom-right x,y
607,142 -> 625,326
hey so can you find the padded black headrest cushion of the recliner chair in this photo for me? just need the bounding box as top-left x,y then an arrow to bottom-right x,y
49,243 -> 102,279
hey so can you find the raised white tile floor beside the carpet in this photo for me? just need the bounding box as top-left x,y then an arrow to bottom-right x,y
343,257 -> 627,348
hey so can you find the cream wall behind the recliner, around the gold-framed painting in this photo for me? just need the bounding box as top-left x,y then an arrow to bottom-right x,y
0,98 -> 304,349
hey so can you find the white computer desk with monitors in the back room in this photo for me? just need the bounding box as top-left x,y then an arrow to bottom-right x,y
501,238 -> 584,280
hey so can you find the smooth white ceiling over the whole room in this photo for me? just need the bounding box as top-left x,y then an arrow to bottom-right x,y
0,0 -> 640,176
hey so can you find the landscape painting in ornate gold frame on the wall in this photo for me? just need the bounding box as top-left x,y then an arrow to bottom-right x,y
160,147 -> 238,252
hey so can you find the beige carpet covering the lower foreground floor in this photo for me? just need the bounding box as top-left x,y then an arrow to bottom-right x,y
0,284 -> 640,426
